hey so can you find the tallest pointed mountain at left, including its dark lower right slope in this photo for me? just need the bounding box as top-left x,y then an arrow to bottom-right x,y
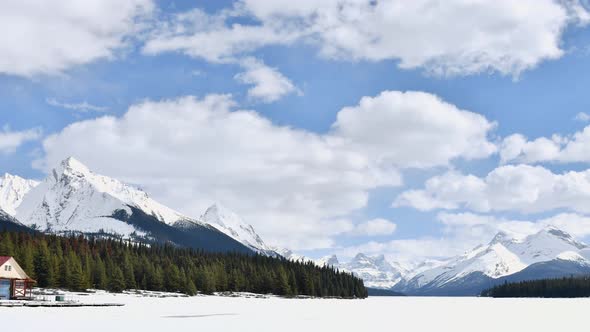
0,158 -> 252,253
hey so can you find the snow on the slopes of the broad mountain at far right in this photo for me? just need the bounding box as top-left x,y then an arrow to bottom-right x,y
406,227 -> 590,289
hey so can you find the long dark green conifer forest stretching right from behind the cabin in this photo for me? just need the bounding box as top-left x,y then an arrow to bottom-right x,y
0,231 -> 367,298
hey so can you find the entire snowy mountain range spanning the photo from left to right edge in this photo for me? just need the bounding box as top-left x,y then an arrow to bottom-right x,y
0,158 -> 590,295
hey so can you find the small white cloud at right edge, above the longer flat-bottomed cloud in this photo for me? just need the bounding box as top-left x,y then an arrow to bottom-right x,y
500,126 -> 590,164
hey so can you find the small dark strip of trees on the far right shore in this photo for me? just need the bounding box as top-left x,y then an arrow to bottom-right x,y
481,276 -> 590,298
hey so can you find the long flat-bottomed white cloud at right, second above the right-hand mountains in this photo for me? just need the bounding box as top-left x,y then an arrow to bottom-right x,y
394,165 -> 590,213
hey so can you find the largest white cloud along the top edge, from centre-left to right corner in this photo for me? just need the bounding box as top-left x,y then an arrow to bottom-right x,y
144,0 -> 588,75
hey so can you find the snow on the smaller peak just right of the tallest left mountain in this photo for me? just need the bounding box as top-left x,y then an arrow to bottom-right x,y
200,203 -> 278,256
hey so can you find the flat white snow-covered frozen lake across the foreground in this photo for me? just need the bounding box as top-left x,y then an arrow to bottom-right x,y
0,294 -> 590,332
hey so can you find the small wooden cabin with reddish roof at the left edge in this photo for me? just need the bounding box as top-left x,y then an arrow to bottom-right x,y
0,256 -> 35,300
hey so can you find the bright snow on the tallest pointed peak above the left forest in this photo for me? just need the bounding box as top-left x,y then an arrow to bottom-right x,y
16,158 -> 193,236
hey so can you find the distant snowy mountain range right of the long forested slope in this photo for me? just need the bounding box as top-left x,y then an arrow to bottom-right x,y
298,227 -> 590,296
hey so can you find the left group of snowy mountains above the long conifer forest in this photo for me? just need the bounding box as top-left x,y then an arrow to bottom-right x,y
0,158 -> 272,254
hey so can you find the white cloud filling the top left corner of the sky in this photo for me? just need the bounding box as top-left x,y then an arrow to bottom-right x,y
0,0 -> 153,77
